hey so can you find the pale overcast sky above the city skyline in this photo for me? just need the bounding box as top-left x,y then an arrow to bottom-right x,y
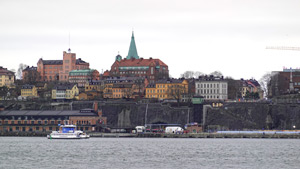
0,0 -> 300,80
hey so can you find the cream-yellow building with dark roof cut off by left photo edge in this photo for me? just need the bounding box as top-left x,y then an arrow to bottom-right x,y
0,66 -> 15,88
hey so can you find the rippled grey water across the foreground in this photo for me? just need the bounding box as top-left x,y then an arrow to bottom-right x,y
0,137 -> 300,169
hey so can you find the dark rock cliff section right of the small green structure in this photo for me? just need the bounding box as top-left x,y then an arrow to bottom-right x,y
206,103 -> 300,130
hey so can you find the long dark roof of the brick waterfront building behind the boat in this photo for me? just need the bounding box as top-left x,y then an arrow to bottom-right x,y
0,110 -> 98,117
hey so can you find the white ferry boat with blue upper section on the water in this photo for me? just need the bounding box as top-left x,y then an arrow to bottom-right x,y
47,125 -> 90,139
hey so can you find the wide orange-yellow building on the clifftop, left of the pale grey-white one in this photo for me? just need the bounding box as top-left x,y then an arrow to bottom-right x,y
146,79 -> 188,100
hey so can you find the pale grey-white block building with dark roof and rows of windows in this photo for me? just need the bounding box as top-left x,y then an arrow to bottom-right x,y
195,75 -> 228,100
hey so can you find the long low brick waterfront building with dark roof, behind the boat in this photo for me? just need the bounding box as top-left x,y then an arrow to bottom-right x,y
0,103 -> 107,132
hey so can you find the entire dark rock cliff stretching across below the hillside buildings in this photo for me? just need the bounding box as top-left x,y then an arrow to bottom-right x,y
0,101 -> 300,130
